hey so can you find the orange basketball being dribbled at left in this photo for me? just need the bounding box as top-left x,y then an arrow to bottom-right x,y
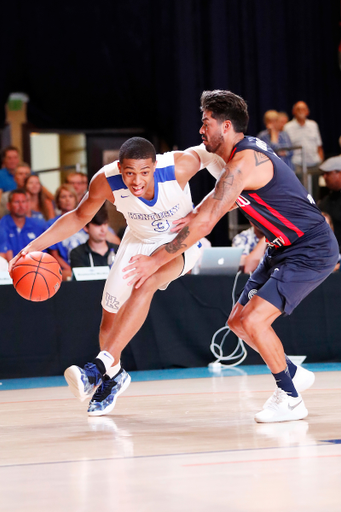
12,251 -> 62,302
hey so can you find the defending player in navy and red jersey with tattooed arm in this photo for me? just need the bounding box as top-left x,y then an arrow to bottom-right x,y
125,90 -> 339,423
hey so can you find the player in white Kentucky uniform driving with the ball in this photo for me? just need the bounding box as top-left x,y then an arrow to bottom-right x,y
9,137 -> 225,416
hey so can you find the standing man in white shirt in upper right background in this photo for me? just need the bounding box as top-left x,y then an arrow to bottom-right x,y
284,101 -> 324,200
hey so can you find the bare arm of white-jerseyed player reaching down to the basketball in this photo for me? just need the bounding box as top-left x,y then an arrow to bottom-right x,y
9,171 -> 114,272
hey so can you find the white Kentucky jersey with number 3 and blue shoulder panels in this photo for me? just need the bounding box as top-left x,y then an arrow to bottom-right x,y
103,152 -> 193,243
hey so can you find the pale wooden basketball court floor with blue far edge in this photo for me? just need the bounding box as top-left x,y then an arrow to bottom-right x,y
0,363 -> 341,512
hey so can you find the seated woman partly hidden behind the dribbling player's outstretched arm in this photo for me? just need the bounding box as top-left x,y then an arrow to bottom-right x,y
47,184 -> 89,281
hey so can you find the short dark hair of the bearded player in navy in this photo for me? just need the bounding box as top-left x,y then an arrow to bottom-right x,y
200,89 -> 249,133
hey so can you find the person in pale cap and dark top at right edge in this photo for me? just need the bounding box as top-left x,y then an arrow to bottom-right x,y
318,155 -> 341,252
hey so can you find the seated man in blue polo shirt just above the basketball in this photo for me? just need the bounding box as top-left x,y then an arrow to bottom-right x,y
0,189 -> 46,256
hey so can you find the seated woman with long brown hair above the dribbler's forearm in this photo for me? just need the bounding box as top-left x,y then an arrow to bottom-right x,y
25,174 -> 56,220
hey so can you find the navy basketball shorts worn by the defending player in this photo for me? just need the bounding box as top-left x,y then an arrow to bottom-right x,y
238,223 -> 339,315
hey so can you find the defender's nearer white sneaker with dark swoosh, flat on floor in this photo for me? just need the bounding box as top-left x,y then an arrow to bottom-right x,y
255,388 -> 308,423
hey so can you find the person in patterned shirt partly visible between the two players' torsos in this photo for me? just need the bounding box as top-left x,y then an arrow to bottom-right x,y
232,222 -> 266,274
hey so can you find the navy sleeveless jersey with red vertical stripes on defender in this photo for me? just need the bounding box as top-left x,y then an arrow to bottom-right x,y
230,136 -> 325,247
